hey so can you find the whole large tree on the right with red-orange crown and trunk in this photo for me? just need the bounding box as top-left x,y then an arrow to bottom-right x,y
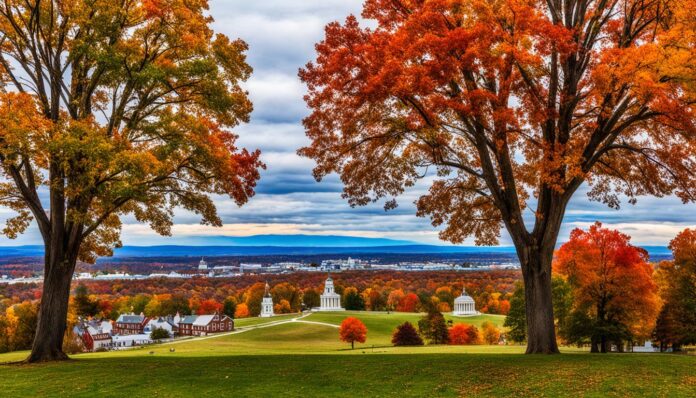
299,0 -> 696,353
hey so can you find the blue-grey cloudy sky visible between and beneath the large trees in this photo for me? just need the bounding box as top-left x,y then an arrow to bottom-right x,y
0,0 -> 696,245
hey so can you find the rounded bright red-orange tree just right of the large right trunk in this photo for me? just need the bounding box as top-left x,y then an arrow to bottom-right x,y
553,223 -> 659,352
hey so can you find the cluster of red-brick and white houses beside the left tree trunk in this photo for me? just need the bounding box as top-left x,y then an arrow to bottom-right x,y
73,313 -> 234,351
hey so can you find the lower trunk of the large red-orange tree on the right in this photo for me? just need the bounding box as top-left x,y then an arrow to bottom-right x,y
521,248 -> 559,354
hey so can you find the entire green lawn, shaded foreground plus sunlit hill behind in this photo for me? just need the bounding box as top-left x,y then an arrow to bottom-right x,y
0,312 -> 696,397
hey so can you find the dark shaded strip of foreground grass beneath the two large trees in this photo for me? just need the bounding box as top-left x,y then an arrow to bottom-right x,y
0,354 -> 696,397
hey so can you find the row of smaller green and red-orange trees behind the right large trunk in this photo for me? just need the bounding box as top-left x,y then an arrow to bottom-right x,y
505,223 -> 696,353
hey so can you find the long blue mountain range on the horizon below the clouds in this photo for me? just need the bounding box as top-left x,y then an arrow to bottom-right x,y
0,235 -> 671,259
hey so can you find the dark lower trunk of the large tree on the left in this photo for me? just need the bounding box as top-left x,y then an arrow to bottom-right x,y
26,251 -> 77,363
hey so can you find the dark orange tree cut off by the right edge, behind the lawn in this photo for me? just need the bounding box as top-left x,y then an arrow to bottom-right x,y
653,228 -> 696,350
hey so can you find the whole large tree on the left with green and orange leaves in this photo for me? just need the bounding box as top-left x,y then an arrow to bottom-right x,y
0,0 -> 262,362
